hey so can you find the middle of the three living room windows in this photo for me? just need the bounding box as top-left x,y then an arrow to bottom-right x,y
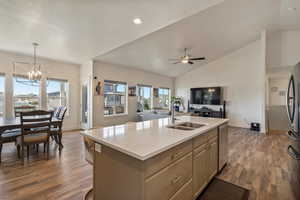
138,85 -> 152,112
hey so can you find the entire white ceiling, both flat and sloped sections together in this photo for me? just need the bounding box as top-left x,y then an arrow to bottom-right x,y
0,0 -> 300,77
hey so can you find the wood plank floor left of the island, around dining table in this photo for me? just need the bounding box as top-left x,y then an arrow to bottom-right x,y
0,132 -> 92,200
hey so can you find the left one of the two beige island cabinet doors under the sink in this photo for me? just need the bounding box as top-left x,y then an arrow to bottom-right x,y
193,145 -> 209,197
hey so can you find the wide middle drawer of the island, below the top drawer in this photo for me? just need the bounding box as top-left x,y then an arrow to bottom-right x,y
145,153 -> 193,200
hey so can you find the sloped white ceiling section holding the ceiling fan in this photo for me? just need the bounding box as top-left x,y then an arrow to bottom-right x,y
96,0 -> 280,77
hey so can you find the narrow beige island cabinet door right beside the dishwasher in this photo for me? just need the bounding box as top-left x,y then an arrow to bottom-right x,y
208,139 -> 218,181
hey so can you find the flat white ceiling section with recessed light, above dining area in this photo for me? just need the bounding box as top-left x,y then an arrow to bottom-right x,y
0,0 -> 223,63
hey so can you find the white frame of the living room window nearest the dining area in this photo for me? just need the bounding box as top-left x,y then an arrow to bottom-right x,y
103,79 -> 128,117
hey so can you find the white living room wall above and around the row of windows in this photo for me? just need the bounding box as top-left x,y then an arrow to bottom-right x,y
93,61 -> 174,126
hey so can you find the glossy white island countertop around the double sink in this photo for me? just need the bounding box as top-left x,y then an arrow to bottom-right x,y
81,116 -> 229,161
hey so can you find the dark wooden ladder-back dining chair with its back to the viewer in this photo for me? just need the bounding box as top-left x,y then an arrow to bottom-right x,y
16,110 -> 53,163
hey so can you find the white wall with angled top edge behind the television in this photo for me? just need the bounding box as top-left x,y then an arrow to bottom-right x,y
175,40 -> 266,131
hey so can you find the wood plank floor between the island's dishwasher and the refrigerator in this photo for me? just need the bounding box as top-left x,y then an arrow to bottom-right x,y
218,128 -> 296,200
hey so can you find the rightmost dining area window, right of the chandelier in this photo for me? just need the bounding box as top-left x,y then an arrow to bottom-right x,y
46,78 -> 69,112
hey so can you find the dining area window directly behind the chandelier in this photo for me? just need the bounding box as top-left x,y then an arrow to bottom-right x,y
14,76 -> 40,116
